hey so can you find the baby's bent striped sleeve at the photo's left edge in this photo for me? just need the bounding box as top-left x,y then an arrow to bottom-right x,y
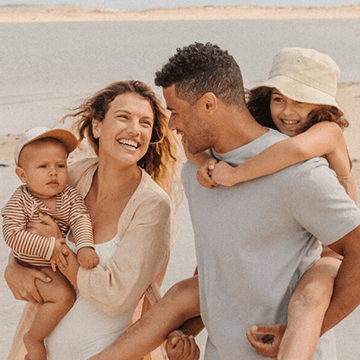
2,189 -> 55,260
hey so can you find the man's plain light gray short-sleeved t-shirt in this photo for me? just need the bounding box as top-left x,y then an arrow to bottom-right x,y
182,130 -> 360,360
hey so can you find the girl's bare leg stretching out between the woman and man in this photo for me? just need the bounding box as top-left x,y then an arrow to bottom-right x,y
91,275 -> 200,360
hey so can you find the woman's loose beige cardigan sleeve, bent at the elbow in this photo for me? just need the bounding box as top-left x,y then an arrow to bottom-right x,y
77,196 -> 171,316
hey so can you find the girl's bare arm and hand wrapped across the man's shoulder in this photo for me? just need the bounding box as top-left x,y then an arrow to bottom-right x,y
210,122 -> 350,186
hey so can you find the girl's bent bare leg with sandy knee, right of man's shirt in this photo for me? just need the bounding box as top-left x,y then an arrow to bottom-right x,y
277,257 -> 341,360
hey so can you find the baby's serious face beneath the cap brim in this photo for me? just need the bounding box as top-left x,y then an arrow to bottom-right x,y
18,139 -> 68,199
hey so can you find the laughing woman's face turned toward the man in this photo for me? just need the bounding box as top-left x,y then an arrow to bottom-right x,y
93,93 -> 154,166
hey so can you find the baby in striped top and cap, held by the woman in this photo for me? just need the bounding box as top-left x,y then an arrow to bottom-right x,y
2,127 -> 99,360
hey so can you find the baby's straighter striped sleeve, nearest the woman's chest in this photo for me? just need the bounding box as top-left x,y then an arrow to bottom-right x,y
69,187 -> 94,250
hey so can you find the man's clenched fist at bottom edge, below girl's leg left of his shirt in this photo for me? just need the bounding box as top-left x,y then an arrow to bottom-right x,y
165,330 -> 200,360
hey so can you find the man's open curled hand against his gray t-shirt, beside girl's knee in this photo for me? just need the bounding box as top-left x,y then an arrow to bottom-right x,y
246,325 -> 286,359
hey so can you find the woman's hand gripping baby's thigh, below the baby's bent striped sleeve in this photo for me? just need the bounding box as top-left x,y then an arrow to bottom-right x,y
5,256 -> 51,304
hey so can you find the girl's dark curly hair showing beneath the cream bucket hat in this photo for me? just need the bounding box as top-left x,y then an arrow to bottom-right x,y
246,86 -> 349,134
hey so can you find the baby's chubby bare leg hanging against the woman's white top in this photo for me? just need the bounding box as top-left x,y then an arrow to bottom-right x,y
24,268 -> 75,360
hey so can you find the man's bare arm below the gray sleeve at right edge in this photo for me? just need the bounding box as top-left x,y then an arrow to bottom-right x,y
321,225 -> 360,334
